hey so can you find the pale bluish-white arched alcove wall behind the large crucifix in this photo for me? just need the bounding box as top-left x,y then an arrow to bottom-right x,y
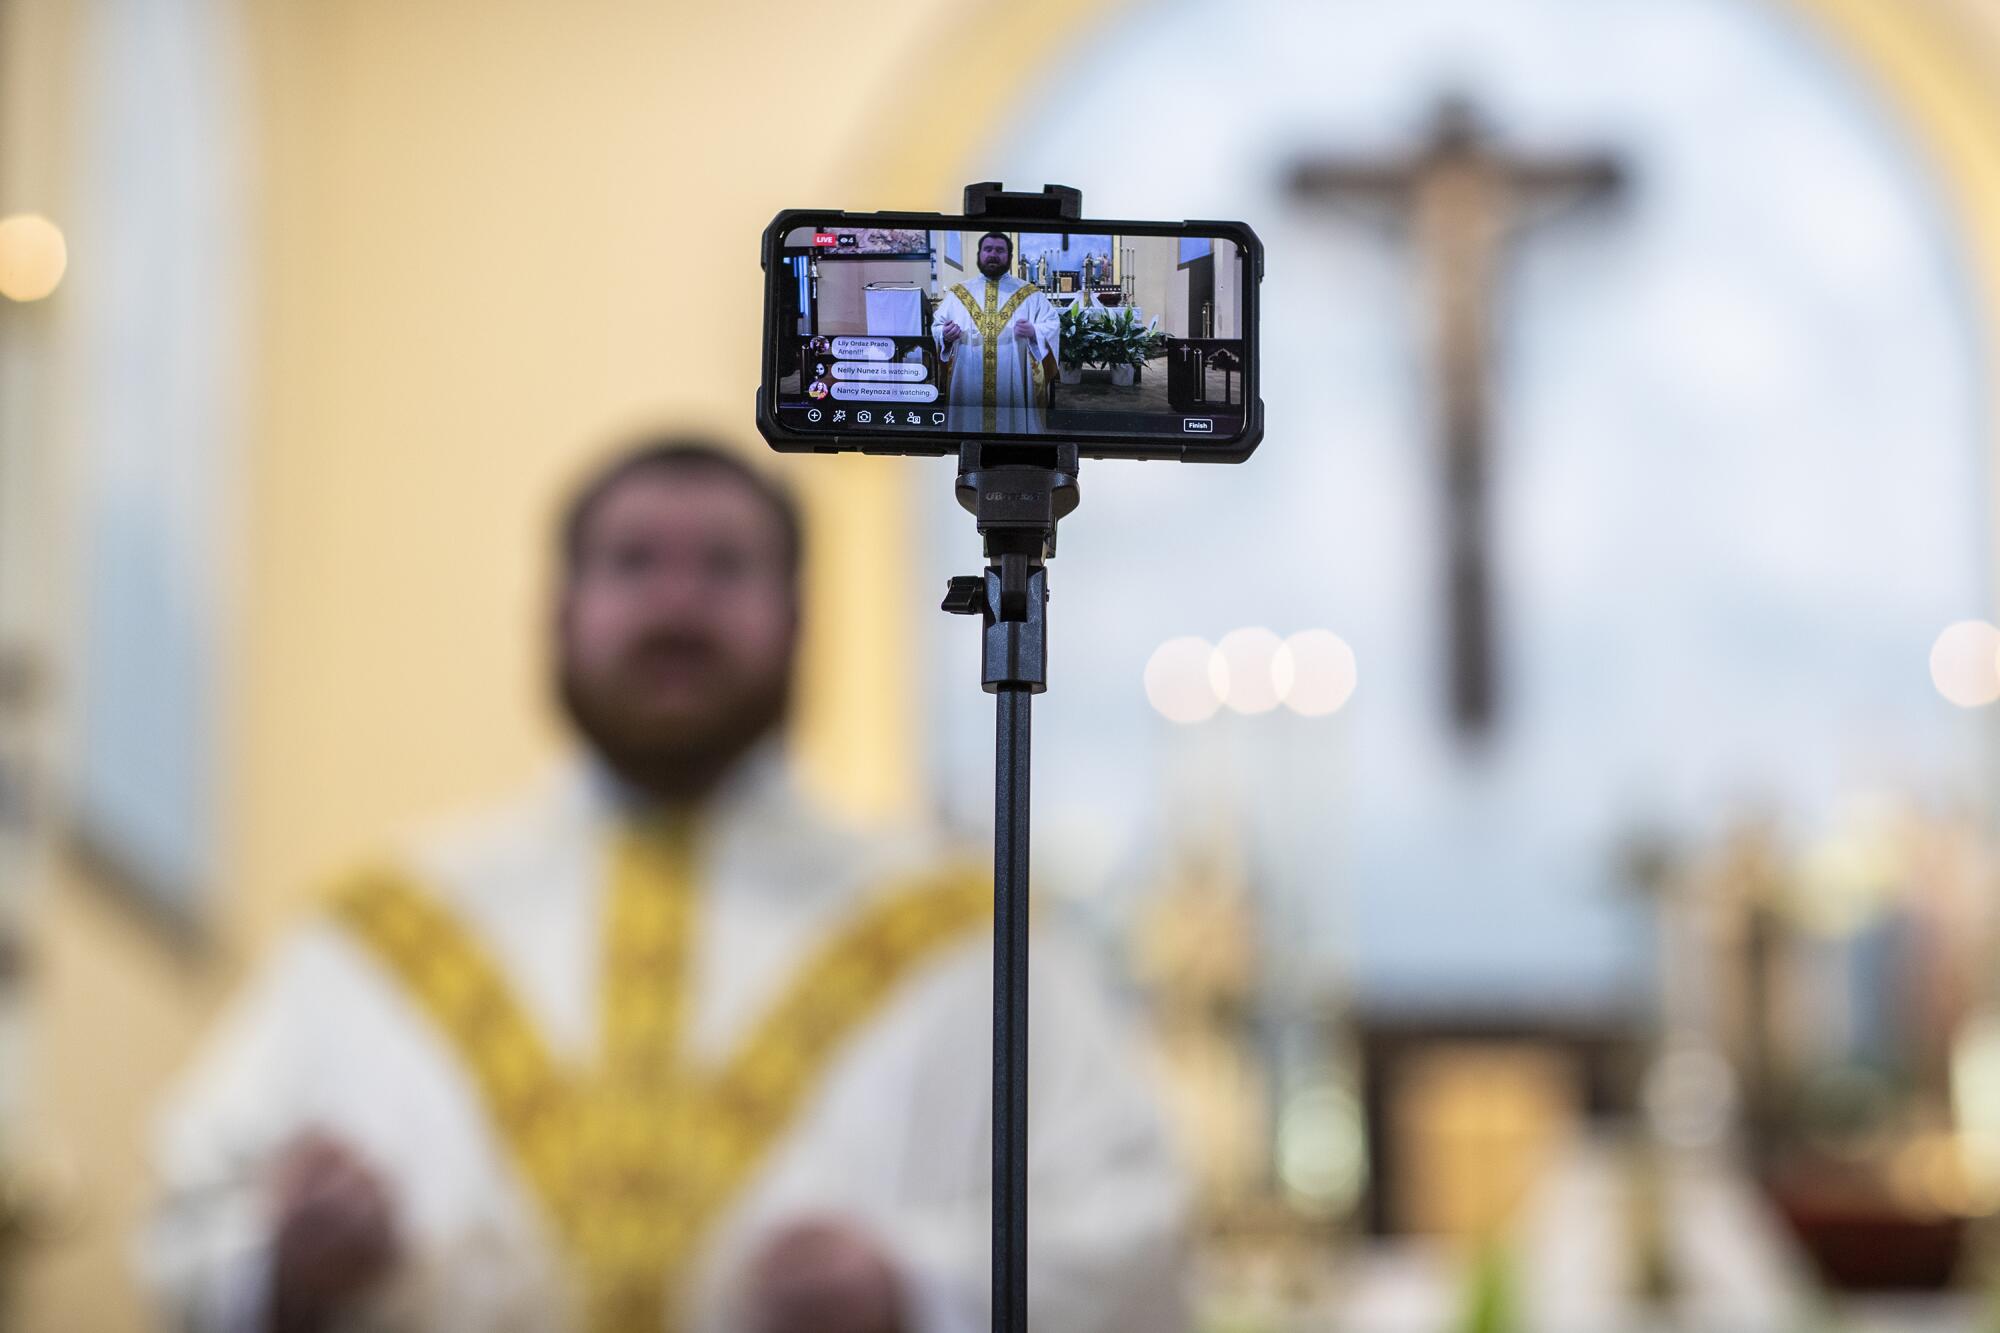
924,0 -> 1992,1005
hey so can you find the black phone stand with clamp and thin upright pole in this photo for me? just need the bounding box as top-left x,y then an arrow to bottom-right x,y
944,180 -> 1082,1333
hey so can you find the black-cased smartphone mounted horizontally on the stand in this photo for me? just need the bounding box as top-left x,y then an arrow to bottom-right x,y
756,210 -> 1264,462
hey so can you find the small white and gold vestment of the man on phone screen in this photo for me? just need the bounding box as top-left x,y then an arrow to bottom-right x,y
930,272 -> 1062,434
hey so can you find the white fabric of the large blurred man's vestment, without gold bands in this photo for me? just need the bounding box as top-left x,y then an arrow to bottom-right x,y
156,753 -> 1184,1333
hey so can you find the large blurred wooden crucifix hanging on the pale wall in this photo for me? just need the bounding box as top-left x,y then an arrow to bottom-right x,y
1292,98 -> 1624,739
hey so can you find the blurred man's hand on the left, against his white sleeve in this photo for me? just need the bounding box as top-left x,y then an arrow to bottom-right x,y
270,1135 -> 398,1333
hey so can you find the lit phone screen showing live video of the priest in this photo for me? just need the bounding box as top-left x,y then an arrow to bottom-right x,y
776,224 -> 1244,438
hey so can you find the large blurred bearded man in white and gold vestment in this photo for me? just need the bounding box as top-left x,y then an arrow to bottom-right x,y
146,440 -> 1182,1333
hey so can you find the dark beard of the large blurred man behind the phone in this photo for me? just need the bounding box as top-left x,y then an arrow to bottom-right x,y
556,644 -> 792,805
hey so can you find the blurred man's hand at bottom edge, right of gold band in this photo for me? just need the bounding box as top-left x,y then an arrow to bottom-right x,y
750,1219 -> 902,1333
